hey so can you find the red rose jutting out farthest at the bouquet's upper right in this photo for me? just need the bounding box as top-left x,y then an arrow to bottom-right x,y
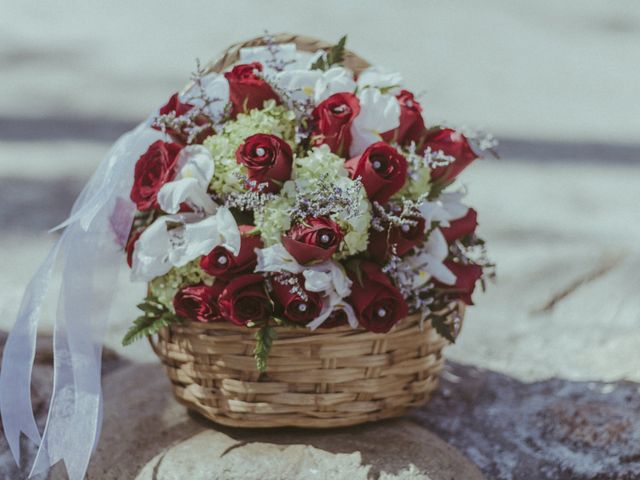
424,128 -> 478,183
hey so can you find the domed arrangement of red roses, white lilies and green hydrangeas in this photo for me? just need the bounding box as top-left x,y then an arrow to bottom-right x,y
123,34 -> 495,371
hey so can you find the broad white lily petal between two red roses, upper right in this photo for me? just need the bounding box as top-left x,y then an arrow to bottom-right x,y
349,88 -> 400,157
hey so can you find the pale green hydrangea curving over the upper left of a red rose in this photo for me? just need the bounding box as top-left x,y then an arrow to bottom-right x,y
204,100 -> 295,196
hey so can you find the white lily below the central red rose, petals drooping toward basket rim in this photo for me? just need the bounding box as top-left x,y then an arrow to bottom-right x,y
256,244 -> 358,330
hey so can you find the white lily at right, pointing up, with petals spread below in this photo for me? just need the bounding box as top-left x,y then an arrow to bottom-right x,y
403,228 -> 456,288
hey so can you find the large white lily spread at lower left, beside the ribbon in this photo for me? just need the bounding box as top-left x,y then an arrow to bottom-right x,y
131,207 -> 240,282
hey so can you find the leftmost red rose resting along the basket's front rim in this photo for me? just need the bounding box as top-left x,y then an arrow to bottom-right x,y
173,282 -> 225,323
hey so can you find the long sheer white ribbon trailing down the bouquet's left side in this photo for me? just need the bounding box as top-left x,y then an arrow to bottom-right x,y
0,119 -> 161,480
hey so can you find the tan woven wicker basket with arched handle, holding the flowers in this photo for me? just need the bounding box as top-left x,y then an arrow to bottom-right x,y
149,34 -> 464,428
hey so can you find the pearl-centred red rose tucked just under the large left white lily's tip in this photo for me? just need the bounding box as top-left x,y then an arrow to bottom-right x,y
200,225 -> 262,280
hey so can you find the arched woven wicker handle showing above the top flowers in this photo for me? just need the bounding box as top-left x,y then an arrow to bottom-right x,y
206,33 -> 370,75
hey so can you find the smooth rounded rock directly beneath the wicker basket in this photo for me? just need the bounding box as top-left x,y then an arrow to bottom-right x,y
88,365 -> 483,480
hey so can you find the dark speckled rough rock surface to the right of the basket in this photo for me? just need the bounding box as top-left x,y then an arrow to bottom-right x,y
410,363 -> 640,480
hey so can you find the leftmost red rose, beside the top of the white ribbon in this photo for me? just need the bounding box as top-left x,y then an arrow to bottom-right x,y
130,140 -> 182,211
